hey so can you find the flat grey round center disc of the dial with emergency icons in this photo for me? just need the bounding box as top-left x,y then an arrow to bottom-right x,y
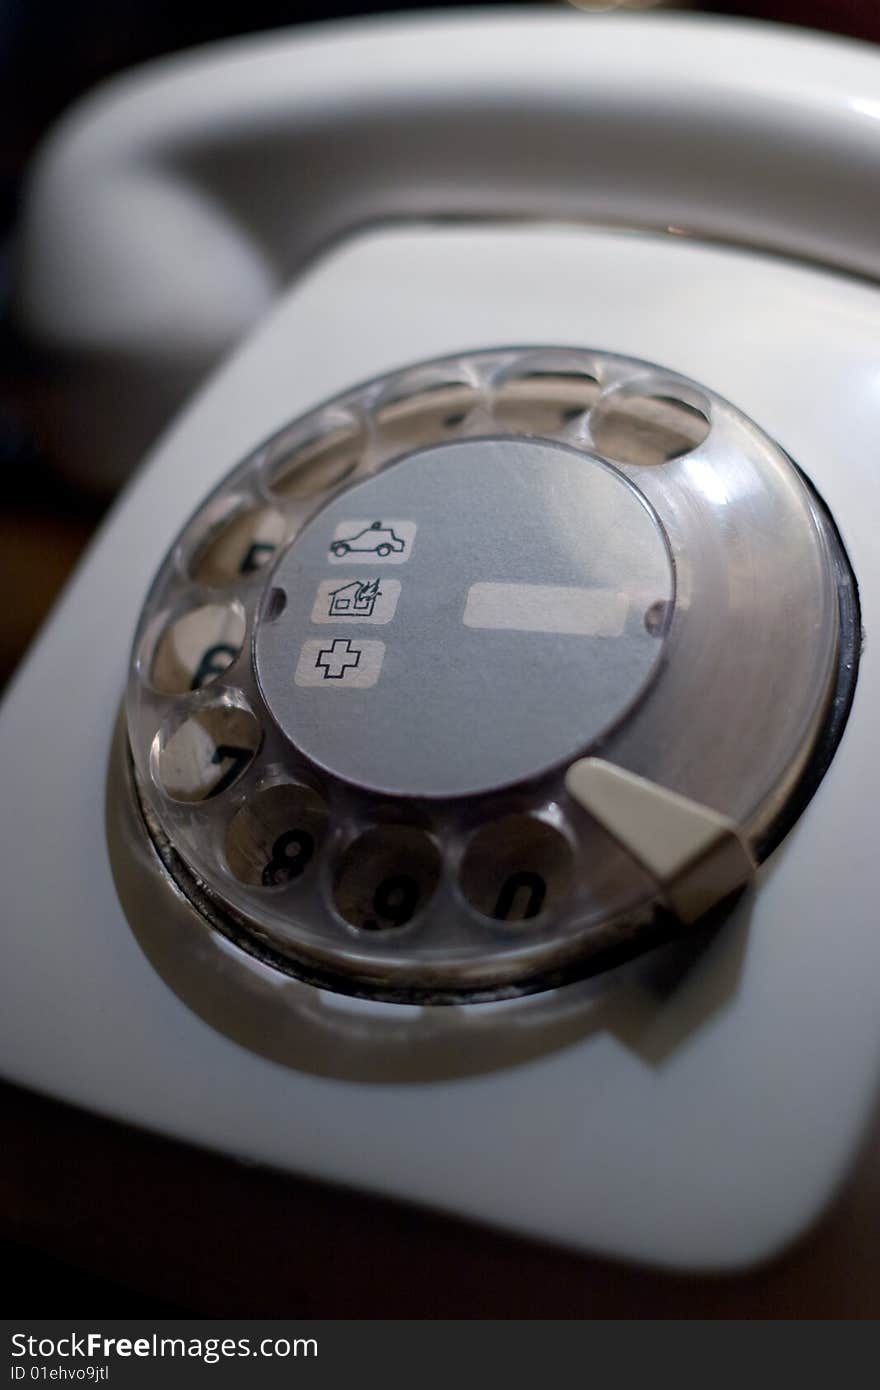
256,438 -> 673,796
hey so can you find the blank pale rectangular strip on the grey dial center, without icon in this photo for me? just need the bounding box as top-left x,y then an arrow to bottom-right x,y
462,584 -> 630,637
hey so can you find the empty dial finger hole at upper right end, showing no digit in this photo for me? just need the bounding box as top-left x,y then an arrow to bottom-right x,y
589,391 -> 709,467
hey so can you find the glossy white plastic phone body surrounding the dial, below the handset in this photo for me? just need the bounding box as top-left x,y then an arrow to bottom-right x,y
0,227 -> 880,1269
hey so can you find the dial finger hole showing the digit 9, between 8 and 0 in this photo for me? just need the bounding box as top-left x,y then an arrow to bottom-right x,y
334,826 -> 441,931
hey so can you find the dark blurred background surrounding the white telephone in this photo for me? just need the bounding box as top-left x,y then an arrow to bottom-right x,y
0,0 -> 880,1316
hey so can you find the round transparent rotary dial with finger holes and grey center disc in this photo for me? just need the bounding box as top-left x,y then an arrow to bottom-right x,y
127,348 -> 859,1002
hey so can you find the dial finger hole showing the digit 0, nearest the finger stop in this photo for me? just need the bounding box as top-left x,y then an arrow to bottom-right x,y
460,815 -> 574,922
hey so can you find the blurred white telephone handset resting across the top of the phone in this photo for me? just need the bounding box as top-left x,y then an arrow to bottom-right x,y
18,11 -> 880,487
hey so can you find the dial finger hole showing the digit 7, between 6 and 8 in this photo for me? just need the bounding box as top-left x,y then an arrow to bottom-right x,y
152,703 -> 261,802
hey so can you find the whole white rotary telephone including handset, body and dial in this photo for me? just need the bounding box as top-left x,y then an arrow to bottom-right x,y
0,5 -> 880,1268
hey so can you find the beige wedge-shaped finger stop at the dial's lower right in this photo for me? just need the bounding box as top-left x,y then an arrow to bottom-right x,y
566,758 -> 755,924
